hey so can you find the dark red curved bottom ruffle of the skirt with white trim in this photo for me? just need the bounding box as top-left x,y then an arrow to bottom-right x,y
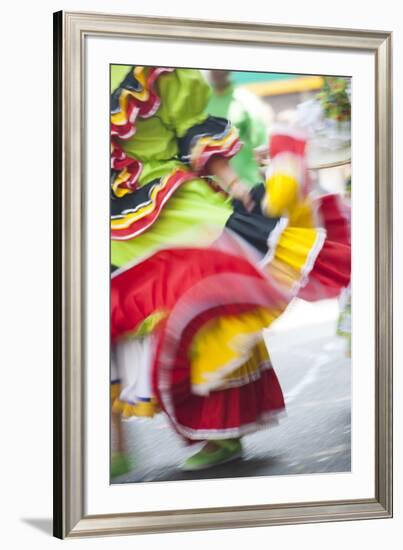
148,270 -> 286,440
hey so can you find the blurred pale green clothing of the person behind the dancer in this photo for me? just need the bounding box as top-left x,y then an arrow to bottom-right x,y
207,86 -> 268,186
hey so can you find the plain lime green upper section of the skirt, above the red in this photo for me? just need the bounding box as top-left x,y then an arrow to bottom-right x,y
111,179 -> 232,267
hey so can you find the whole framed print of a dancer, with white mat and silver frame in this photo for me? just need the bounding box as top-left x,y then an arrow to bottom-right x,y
54,12 -> 392,538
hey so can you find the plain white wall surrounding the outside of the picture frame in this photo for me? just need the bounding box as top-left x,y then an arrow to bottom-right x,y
0,0 -> 403,550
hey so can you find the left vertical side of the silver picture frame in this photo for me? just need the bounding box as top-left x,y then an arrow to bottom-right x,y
60,12 -> 85,538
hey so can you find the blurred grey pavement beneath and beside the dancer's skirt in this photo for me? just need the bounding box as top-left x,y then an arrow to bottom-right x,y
112,300 -> 351,483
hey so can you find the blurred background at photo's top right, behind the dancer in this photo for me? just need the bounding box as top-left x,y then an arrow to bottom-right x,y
203,70 -> 351,195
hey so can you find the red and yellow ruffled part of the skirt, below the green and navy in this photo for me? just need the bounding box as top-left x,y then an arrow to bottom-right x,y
111,210 -> 350,441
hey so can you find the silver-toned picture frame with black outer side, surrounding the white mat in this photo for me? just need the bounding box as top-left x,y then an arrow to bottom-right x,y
54,12 -> 392,538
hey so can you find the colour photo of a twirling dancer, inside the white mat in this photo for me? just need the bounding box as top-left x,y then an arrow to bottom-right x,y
109,64 -> 354,484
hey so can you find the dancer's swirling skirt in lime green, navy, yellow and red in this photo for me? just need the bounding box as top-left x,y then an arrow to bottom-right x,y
111,179 -> 350,441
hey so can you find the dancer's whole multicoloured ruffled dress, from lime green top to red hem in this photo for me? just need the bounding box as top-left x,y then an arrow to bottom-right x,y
111,66 -> 350,448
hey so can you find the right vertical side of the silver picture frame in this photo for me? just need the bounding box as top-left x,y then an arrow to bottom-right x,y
375,34 -> 393,517
